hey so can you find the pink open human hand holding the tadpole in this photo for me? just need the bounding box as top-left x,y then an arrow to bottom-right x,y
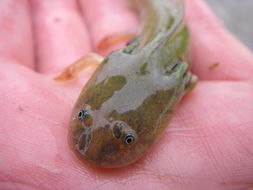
0,0 -> 253,190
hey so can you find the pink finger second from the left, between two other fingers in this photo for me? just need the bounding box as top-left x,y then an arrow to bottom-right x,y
32,0 -> 90,73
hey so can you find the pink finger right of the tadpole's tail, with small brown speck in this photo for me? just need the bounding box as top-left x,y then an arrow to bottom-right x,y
186,0 -> 253,80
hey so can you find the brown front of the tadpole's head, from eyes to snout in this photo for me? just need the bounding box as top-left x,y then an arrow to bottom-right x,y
69,106 -> 147,168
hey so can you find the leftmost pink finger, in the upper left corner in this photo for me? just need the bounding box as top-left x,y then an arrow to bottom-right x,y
0,0 -> 34,68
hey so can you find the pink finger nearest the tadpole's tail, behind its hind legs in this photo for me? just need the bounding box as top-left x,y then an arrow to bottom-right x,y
80,0 -> 137,54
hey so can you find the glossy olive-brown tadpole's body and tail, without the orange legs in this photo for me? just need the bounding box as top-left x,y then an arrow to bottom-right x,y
68,0 -> 195,168
